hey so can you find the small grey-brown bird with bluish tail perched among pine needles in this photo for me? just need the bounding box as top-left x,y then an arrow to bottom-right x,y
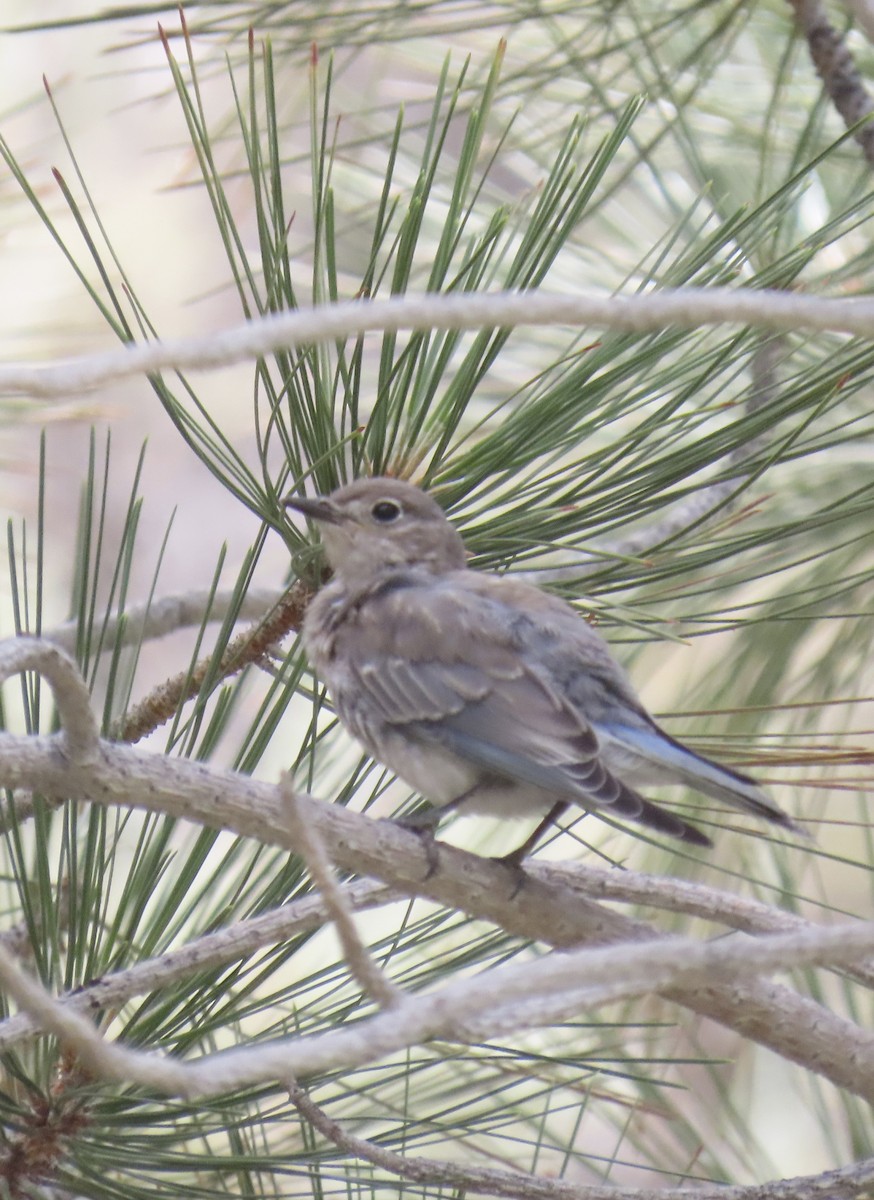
285,478 -> 797,860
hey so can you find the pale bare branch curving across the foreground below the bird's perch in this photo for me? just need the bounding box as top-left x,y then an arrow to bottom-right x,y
0,892 -> 874,1098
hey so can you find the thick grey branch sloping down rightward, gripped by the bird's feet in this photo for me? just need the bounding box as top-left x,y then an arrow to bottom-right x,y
0,734 -> 874,1099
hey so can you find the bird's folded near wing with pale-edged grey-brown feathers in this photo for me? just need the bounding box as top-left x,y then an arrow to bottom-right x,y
333,583 -> 710,845
